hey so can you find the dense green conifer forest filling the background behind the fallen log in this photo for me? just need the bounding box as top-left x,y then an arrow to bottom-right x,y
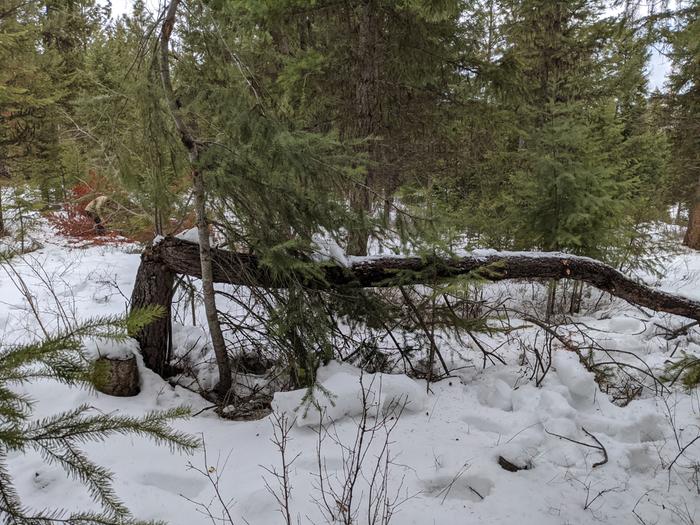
0,0 -> 700,255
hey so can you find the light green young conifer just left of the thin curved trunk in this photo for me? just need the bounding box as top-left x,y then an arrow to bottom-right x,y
73,2 -> 187,235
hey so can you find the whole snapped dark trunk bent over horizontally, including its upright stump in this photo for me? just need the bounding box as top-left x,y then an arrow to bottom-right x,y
131,237 -> 700,374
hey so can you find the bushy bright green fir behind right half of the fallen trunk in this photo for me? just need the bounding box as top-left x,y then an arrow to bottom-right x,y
486,0 -> 628,256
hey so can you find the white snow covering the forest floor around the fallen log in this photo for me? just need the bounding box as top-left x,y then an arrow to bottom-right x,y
0,223 -> 700,525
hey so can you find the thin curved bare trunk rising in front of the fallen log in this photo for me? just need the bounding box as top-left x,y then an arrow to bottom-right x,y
160,0 -> 232,396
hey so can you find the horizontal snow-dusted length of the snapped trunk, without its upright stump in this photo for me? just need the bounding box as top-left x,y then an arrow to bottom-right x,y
147,237 -> 700,321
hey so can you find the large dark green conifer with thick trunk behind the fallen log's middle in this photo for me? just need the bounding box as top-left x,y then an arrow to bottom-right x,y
214,0 -> 466,255
